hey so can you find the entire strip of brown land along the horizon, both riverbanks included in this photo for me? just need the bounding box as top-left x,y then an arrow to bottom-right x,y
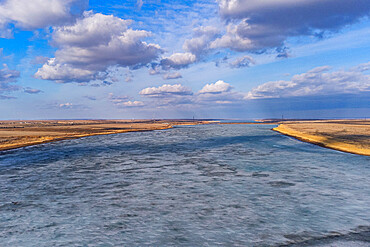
0,119 -> 370,156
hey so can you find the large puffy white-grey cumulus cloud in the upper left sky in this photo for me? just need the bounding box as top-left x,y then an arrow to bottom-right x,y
35,11 -> 161,82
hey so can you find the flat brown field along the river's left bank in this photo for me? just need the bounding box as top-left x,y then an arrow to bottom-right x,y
0,120 -> 212,151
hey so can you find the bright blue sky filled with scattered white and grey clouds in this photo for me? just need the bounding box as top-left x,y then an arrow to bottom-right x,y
0,0 -> 370,120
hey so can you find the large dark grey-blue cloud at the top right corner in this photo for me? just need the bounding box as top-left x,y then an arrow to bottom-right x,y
212,0 -> 370,51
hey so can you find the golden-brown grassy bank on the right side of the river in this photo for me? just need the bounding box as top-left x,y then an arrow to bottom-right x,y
273,120 -> 370,156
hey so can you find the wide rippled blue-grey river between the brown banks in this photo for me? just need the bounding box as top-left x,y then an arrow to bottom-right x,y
0,125 -> 370,247
